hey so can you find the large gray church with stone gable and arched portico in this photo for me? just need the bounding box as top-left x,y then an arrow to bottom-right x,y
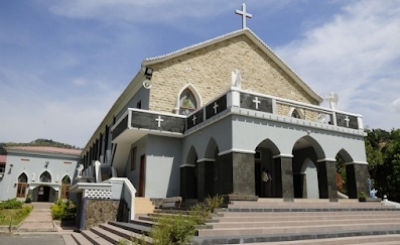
81,7 -> 369,201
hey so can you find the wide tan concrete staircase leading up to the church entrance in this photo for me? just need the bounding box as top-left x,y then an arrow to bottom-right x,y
64,199 -> 400,245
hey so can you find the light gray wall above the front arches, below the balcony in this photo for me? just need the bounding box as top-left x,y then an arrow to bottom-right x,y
232,115 -> 366,163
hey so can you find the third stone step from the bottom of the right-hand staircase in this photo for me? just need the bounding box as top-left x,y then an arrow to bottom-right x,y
198,222 -> 400,236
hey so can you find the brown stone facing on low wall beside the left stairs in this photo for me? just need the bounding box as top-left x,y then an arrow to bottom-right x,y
83,199 -> 119,230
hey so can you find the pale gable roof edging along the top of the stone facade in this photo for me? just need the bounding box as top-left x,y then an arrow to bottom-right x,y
142,28 -> 323,103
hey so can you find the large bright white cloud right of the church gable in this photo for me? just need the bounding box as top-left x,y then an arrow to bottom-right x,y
277,0 -> 400,128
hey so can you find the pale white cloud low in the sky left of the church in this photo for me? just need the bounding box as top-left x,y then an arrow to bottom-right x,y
0,80 -> 121,147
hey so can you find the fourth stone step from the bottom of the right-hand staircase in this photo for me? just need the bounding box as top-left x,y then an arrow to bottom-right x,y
206,218 -> 399,229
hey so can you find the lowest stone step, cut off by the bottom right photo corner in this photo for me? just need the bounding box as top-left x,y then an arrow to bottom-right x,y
228,235 -> 400,245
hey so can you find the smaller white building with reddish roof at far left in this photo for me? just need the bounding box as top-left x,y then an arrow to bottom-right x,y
0,146 -> 81,202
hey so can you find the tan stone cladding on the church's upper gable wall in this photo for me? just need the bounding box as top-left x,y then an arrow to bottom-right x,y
149,34 -> 318,115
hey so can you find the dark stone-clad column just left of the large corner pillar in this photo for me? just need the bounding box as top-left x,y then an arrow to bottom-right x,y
197,158 -> 215,201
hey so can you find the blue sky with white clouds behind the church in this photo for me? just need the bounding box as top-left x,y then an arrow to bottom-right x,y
0,0 -> 400,147
